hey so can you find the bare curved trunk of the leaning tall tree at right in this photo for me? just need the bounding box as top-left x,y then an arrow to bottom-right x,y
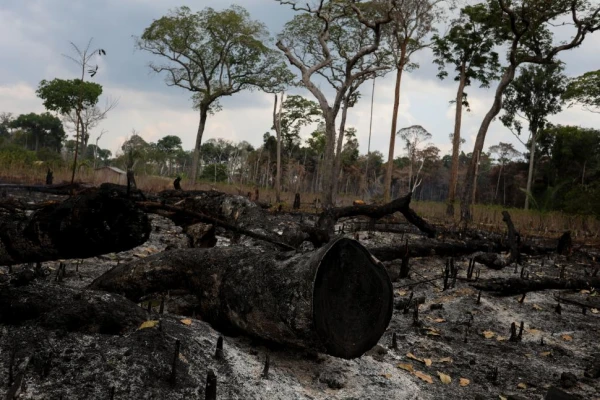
460,63 -> 518,225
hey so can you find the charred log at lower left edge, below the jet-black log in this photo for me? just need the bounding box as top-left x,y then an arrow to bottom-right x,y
0,283 -> 147,335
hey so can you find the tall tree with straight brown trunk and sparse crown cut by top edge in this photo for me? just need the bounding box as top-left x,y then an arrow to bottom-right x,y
383,0 -> 447,202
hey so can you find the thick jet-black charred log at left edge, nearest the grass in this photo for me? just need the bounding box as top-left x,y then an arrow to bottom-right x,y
0,188 -> 151,265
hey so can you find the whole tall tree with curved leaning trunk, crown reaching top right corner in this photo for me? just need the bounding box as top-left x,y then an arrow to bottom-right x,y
461,0 -> 600,225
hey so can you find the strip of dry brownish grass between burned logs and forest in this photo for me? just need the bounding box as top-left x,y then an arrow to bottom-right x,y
0,165 -> 600,242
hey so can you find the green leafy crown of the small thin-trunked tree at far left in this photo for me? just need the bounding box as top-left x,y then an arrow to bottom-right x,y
36,78 -> 102,114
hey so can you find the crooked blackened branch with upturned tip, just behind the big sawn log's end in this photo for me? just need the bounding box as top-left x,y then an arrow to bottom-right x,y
317,193 -> 436,238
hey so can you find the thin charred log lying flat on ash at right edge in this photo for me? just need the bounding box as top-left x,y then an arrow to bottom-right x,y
471,278 -> 600,296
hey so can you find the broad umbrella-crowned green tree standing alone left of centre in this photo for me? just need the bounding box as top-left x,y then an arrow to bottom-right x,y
136,5 -> 289,182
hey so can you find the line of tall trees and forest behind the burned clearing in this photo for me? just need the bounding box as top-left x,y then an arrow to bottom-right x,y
3,0 -> 600,222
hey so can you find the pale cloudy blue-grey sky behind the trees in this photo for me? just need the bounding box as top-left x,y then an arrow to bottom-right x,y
0,0 -> 600,161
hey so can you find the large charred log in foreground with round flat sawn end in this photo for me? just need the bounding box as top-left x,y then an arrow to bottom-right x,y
90,238 -> 393,359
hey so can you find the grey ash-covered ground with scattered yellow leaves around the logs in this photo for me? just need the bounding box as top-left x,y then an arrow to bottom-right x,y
0,189 -> 600,400
